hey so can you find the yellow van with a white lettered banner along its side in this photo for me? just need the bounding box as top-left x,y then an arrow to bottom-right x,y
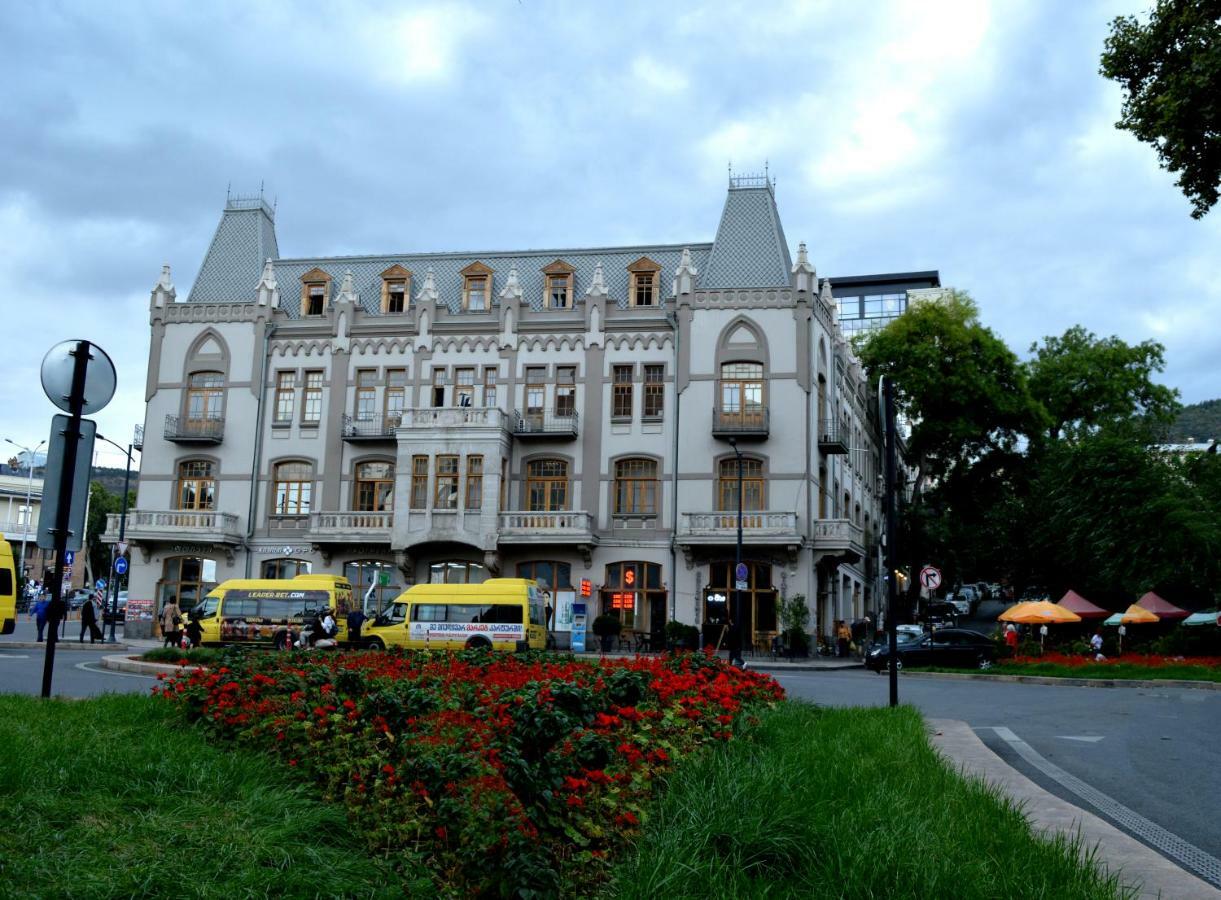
361,578 -> 547,651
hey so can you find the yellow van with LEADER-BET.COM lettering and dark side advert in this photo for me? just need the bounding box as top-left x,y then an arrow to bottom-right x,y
189,575 -> 352,650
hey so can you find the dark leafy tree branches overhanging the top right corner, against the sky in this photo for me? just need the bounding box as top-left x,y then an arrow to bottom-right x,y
1099,0 -> 1221,219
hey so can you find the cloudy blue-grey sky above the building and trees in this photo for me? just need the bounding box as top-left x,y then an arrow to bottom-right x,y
0,0 -> 1221,464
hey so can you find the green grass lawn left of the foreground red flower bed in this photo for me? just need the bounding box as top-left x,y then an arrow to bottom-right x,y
0,695 -> 420,898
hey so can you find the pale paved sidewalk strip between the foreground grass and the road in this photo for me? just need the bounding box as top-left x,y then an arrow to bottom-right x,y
928,719 -> 1221,900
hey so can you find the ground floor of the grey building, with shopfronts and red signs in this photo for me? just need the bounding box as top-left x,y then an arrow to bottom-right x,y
119,532 -> 869,651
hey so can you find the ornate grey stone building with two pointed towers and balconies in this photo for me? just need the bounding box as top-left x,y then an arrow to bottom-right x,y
107,177 -> 937,644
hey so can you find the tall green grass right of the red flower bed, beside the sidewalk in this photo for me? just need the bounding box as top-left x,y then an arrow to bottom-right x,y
613,702 -> 1123,900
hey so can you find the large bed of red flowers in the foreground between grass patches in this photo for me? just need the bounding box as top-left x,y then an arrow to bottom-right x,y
155,652 -> 784,895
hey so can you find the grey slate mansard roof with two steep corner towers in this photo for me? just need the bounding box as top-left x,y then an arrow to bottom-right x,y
187,178 -> 792,316
